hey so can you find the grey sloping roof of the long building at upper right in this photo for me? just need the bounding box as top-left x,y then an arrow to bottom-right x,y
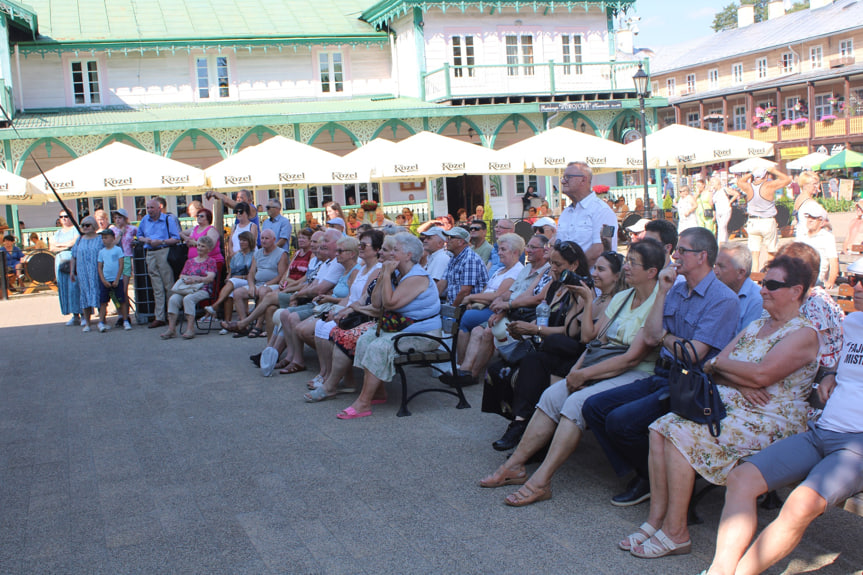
650,0 -> 863,75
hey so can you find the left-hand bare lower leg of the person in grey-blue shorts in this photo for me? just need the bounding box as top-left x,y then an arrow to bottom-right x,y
707,463 -> 767,575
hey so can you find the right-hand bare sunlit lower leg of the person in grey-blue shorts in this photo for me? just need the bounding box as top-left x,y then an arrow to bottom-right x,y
737,485 -> 827,575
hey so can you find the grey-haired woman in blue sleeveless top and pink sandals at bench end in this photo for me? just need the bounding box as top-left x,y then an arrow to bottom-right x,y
336,232 -> 441,419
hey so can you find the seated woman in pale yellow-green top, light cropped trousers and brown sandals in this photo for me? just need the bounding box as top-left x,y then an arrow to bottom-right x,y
480,238 -> 665,507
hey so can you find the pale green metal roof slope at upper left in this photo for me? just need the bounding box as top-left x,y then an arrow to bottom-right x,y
16,0 -> 378,43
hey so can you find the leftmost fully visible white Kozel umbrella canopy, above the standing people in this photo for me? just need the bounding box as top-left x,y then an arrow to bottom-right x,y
30,142 -> 206,199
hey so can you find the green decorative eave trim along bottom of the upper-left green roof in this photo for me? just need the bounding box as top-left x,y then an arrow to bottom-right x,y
17,32 -> 389,57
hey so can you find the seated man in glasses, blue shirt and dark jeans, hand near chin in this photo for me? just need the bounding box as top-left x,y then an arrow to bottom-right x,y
582,228 -> 740,506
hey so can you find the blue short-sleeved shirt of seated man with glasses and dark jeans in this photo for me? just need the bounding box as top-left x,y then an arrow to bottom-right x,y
660,270 -> 740,360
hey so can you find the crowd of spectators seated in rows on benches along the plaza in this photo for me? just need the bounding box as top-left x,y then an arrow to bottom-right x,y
50,180 -> 852,575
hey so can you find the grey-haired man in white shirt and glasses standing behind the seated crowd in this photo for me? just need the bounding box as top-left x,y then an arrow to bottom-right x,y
556,162 -> 617,266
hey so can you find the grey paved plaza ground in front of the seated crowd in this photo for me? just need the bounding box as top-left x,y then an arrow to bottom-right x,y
0,296 -> 863,575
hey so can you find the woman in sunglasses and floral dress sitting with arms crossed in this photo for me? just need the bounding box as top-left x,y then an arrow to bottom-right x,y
619,256 -> 818,559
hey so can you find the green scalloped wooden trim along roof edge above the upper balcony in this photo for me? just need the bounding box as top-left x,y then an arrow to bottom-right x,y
360,0 -> 635,28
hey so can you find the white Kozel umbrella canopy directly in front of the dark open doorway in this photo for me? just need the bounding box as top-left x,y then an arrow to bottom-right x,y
374,132 -> 523,181
